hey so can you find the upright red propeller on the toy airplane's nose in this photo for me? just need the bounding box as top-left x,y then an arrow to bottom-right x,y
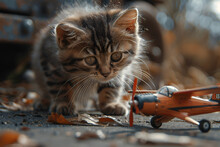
129,78 -> 139,127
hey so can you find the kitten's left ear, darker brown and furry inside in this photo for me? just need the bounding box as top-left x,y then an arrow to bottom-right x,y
55,23 -> 85,49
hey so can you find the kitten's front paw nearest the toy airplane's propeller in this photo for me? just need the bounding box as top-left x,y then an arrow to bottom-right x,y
101,102 -> 128,115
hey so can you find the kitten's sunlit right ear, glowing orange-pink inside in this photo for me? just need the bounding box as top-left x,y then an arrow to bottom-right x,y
113,8 -> 138,34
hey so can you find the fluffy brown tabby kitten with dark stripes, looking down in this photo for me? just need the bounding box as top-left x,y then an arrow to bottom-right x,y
32,3 -> 145,115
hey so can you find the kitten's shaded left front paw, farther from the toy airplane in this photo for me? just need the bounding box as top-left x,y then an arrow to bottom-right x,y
50,102 -> 72,115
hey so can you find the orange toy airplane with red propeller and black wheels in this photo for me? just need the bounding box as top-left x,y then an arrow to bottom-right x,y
129,79 -> 220,132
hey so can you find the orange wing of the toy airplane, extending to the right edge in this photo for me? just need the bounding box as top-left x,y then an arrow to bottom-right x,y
173,86 -> 220,99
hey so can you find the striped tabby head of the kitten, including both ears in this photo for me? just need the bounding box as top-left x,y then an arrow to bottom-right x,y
55,9 -> 139,82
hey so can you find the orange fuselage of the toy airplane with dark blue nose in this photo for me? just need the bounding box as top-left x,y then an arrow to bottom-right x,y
137,93 -> 220,116
